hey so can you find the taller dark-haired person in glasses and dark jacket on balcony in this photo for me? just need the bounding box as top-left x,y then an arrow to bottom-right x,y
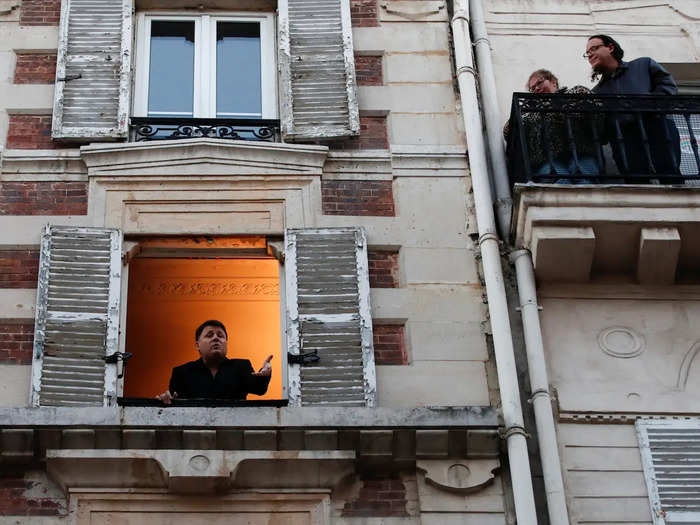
583,35 -> 681,175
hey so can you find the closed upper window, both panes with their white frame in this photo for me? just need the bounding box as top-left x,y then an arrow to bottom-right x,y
134,13 -> 277,119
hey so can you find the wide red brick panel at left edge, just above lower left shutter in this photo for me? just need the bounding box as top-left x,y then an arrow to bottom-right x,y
0,182 -> 87,215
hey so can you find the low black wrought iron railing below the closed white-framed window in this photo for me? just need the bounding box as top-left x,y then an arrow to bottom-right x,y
131,117 -> 280,142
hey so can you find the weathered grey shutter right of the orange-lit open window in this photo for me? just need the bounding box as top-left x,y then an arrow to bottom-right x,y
285,228 -> 376,407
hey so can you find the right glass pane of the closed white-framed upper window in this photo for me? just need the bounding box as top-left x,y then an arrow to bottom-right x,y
216,22 -> 262,118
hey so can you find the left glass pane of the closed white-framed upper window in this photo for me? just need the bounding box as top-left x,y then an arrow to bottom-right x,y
148,20 -> 194,117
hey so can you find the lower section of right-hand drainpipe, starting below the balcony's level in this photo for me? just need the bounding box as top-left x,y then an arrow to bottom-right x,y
511,250 -> 569,525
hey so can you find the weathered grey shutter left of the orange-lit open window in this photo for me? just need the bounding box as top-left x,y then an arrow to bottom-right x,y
31,225 -> 122,406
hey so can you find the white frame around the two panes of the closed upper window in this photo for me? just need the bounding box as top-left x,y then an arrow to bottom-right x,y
132,11 -> 278,119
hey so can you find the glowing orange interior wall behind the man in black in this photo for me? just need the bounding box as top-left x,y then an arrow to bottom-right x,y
124,257 -> 282,399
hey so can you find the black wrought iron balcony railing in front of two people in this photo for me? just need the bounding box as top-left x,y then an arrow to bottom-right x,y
504,93 -> 700,185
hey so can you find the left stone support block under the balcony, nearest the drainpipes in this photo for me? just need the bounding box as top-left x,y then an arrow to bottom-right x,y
531,226 -> 595,282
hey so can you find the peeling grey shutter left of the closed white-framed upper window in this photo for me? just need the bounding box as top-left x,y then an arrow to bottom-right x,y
52,0 -> 132,140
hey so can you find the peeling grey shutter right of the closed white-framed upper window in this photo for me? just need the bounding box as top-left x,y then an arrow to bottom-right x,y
278,0 -> 360,141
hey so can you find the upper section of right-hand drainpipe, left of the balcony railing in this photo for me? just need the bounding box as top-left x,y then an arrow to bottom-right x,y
469,0 -> 513,235
